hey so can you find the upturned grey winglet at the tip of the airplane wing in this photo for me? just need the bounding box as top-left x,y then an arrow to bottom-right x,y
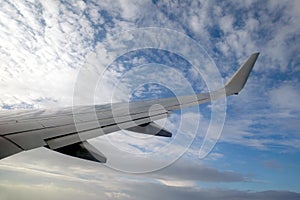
225,52 -> 259,96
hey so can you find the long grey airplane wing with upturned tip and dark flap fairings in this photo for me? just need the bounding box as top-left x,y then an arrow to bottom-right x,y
0,53 -> 259,163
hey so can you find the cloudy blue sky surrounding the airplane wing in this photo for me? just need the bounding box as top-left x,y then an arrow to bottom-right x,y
0,0 -> 300,199
